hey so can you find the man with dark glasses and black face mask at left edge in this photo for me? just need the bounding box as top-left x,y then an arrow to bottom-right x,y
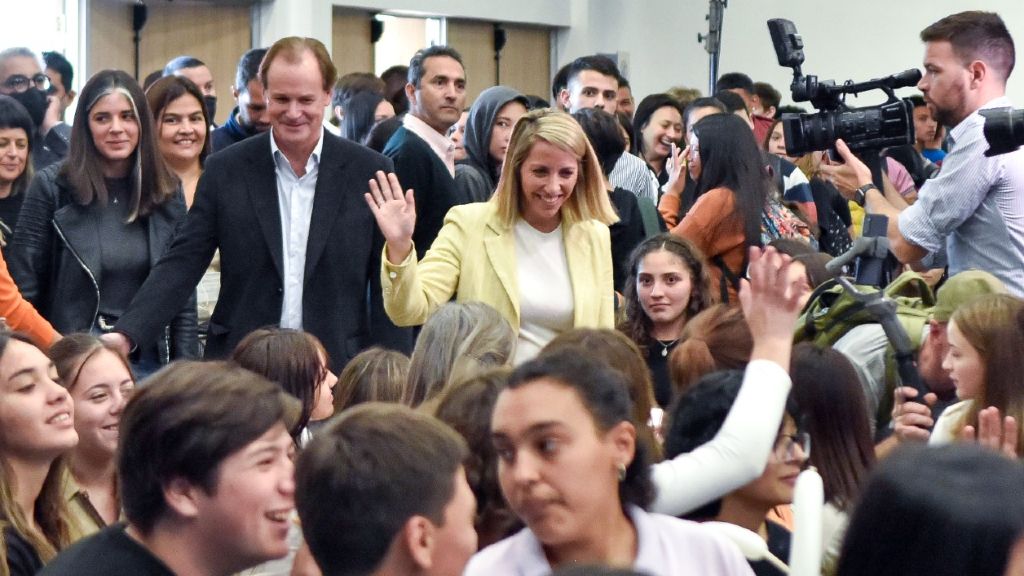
0,47 -> 68,170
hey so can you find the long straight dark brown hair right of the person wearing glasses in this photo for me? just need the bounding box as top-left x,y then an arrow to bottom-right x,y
790,342 -> 874,510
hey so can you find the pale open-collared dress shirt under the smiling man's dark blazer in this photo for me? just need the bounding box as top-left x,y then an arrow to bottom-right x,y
270,130 -> 324,330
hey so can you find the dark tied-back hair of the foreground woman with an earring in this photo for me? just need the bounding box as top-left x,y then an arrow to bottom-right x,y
506,349 -> 654,510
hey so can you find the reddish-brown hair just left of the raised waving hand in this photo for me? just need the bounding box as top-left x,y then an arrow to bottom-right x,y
669,304 -> 754,395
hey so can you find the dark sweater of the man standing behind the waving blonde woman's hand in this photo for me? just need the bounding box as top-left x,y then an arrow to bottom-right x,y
384,126 -> 470,258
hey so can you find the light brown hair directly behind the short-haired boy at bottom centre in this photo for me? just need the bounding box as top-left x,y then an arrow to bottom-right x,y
334,346 -> 409,414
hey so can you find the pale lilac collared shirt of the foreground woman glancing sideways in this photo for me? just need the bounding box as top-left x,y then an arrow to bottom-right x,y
463,506 -> 754,576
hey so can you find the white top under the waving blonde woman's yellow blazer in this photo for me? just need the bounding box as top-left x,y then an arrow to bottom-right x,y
513,218 -> 575,365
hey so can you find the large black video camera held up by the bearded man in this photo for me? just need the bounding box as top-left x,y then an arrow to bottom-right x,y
768,18 -> 921,156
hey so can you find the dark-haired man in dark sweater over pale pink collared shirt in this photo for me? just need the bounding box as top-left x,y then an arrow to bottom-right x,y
384,46 -> 472,258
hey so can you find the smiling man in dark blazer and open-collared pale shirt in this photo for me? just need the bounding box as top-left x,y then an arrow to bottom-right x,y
106,37 -> 412,370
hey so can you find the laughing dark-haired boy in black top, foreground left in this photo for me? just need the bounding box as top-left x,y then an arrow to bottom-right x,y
43,362 -> 300,576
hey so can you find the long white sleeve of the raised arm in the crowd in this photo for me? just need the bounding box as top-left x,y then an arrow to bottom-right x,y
650,360 -> 792,516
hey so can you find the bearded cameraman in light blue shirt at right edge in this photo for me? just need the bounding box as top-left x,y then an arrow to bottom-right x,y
822,11 -> 1024,296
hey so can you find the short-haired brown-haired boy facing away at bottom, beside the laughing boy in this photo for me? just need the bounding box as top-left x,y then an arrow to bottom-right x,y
296,403 -> 477,576
